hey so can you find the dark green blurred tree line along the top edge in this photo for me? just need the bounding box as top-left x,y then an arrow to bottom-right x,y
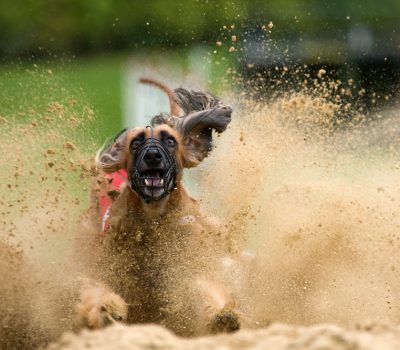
0,0 -> 400,57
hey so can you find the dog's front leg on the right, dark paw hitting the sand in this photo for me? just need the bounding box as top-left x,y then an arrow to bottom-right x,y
195,278 -> 240,333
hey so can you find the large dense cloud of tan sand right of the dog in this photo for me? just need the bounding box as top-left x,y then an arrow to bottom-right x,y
200,90 -> 400,327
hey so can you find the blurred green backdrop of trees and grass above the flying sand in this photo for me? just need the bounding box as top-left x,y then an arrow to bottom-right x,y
0,0 -> 400,140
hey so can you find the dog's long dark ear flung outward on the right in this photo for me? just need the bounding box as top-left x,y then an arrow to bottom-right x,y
176,105 -> 232,168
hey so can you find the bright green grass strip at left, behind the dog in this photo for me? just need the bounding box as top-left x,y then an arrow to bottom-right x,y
0,55 -> 127,142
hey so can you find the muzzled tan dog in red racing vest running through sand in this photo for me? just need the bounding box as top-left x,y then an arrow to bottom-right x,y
72,79 -> 240,336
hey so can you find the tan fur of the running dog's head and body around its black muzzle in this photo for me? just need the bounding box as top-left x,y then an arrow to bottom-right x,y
72,85 -> 239,335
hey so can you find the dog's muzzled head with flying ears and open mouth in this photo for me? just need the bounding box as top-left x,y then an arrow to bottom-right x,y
96,88 -> 232,202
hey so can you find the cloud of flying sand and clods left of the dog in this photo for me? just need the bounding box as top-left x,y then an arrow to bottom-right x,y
0,69 -> 95,348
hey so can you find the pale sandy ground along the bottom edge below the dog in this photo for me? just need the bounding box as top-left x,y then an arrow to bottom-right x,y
46,324 -> 400,350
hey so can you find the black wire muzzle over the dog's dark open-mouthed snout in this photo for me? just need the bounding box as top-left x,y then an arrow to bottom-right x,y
130,130 -> 176,203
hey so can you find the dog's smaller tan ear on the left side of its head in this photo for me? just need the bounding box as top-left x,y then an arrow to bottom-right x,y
96,128 -> 129,173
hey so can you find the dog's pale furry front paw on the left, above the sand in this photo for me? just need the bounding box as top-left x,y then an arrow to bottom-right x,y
77,288 -> 128,329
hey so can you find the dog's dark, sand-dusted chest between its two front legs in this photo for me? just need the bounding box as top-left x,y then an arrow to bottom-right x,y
103,212 -> 200,321
